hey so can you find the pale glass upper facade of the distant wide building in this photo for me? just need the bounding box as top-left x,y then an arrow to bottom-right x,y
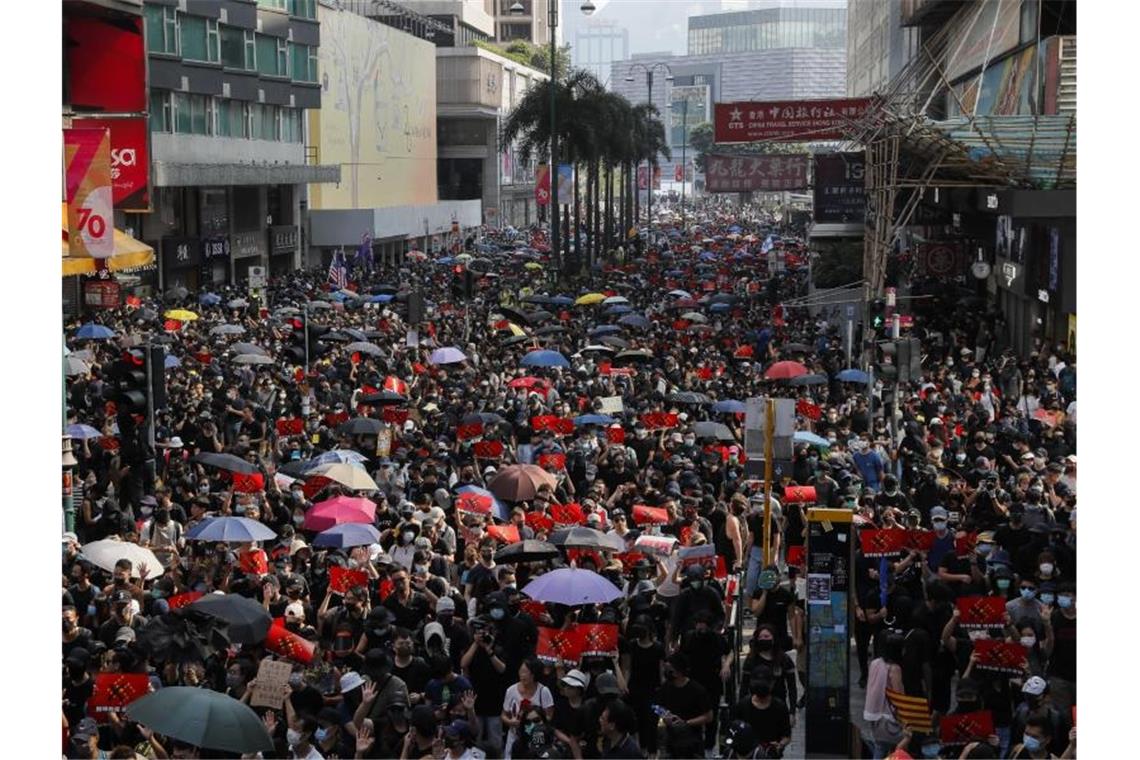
689,8 -> 847,56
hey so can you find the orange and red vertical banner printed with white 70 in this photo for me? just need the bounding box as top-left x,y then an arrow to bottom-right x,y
64,129 -> 115,259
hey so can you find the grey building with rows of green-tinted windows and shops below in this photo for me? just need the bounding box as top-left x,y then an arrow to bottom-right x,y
137,0 -> 341,288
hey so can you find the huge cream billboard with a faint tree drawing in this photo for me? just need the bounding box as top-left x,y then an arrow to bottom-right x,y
309,5 -> 437,210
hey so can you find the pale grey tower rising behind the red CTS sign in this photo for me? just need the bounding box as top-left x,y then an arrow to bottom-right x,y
847,0 -> 918,97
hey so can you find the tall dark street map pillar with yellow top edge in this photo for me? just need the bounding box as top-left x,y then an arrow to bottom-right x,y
804,509 -> 854,758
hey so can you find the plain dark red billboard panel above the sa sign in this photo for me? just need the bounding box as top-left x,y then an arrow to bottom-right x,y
64,13 -> 147,114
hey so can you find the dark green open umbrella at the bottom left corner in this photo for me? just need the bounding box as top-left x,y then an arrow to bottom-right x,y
127,686 -> 274,753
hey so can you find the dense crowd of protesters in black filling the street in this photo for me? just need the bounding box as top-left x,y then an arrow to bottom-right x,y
63,203 -> 1076,760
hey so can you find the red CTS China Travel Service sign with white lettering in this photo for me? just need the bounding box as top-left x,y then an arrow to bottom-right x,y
714,98 -> 871,142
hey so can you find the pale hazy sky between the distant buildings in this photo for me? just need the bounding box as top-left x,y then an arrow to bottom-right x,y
561,0 -> 760,55
